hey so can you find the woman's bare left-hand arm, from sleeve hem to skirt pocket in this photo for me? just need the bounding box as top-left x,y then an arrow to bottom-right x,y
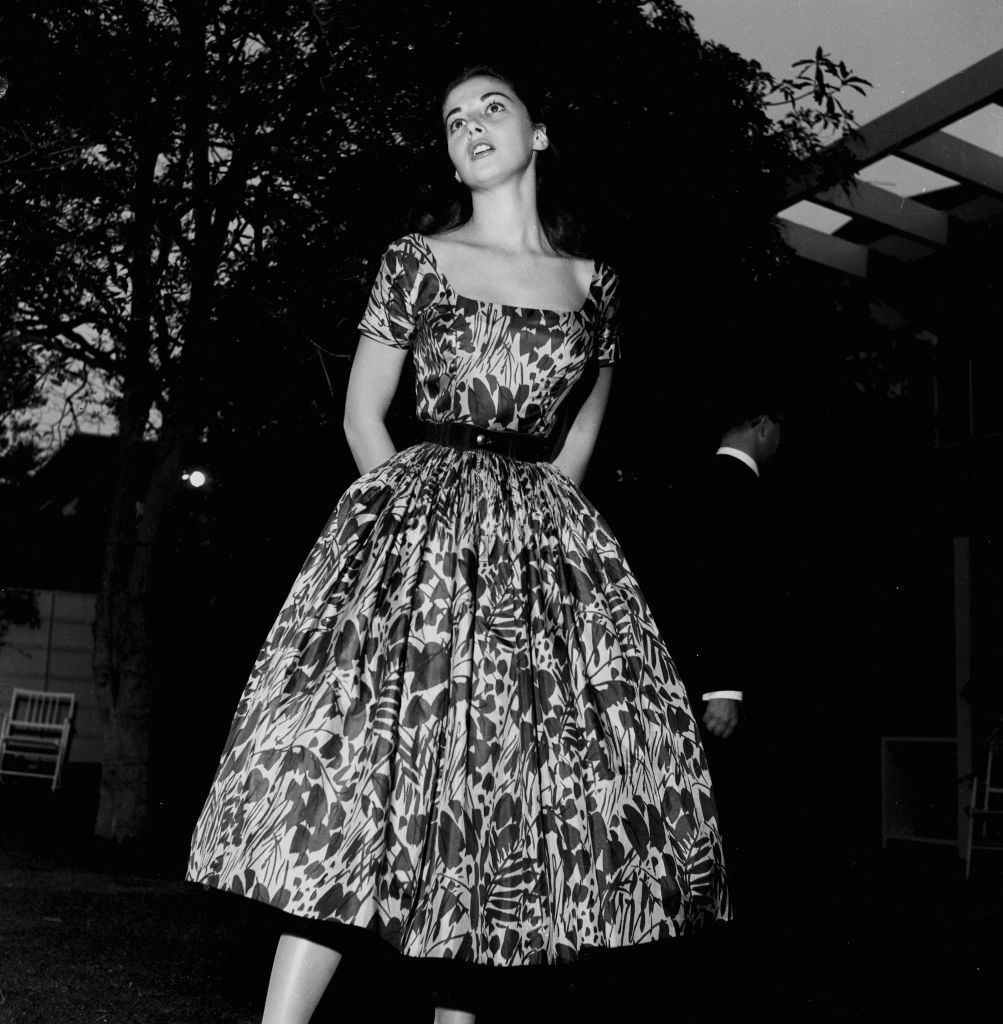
344,335 -> 408,473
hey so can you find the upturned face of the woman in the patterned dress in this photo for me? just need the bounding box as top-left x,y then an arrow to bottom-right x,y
443,76 -> 547,188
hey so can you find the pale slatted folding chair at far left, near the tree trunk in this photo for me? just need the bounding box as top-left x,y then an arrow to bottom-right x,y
0,688 -> 77,792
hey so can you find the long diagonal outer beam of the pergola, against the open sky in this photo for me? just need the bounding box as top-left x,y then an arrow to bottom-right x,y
777,50 -> 1003,210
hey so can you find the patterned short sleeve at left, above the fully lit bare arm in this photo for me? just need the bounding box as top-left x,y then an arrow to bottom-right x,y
359,236 -> 438,348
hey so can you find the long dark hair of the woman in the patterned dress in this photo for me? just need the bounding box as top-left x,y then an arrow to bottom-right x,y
412,65 -> 593,256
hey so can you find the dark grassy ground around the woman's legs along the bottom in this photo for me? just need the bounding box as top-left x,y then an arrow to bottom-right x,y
0,787 -> 1003,1024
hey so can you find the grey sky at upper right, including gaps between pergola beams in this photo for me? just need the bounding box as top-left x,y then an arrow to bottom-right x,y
678,0 -> 1003,230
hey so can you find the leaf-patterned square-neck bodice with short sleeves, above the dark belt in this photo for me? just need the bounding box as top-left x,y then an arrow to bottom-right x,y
352,234 -> 619,434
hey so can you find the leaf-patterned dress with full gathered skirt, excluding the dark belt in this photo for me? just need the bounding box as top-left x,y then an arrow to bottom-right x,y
189,234 -> 729,965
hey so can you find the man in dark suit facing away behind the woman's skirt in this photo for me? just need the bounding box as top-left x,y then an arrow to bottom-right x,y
670,381 -> 783,906
